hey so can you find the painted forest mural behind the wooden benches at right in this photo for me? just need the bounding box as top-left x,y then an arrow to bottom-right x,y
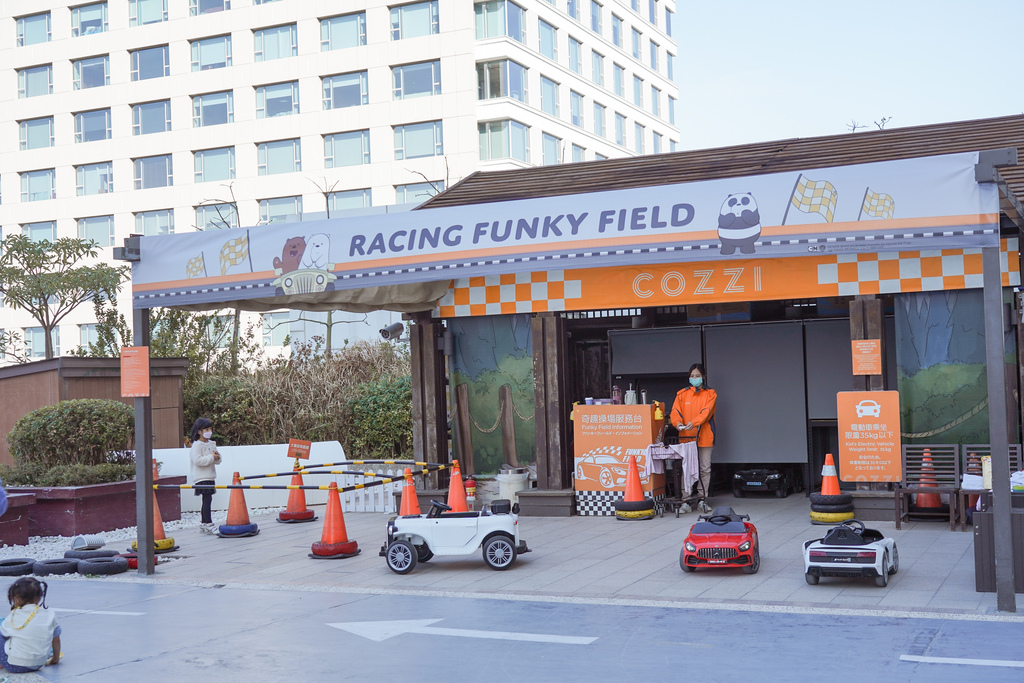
895,289 -> 1018,443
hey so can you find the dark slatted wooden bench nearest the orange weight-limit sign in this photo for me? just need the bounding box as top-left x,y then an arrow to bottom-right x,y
894,443 -> 961,531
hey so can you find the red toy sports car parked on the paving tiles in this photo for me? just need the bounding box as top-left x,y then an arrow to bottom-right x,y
679,506 -> 761,573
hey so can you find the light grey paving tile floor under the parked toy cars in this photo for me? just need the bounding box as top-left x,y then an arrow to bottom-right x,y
125,496 -> 1020,614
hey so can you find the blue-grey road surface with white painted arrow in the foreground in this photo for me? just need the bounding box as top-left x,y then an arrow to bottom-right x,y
11,580 -> 1024,683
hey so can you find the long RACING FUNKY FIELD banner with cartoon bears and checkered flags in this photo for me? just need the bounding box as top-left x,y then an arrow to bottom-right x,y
132,153 -> 998,308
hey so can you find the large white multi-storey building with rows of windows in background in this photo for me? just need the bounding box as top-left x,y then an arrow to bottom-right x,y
0,0 -> 679,357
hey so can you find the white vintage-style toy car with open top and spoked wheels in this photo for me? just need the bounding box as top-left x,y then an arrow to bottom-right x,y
380,499 -> 529,573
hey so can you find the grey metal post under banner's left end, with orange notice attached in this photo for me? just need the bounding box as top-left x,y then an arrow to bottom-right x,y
132,308 -> 156,575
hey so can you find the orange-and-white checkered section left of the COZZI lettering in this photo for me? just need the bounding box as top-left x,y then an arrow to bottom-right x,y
437,270 -> 582,317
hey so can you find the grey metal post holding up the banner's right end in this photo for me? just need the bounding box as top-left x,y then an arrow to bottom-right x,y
981,247 -> 1017,612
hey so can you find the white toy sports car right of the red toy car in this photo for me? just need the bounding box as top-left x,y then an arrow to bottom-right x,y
804,519 -> 899,588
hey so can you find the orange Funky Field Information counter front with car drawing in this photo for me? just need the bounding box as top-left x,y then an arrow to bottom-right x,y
572,404 -> 664,492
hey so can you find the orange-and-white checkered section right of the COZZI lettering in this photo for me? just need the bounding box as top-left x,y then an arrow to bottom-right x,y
818,238 -> 1021,296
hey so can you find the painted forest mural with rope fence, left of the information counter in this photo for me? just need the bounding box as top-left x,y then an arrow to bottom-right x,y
449,313 -> 536,474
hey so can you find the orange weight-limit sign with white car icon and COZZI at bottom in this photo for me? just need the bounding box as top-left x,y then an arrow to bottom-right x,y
836,391 -> 903,481
